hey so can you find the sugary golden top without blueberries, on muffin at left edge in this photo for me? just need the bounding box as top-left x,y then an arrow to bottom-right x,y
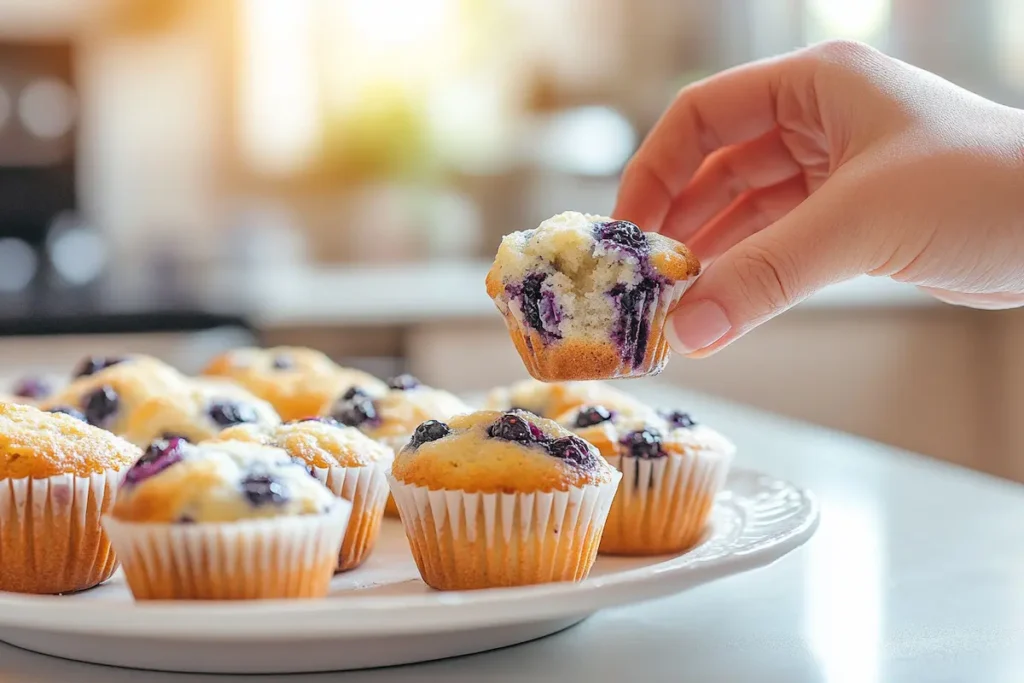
0,403 -> 141,479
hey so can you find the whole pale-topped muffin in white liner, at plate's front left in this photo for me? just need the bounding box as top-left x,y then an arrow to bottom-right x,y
103,438 -> 350,600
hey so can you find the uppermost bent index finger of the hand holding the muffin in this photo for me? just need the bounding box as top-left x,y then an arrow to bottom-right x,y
612,56 -> 801,231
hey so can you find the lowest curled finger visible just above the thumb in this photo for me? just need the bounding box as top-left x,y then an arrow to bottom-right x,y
687,175 -> 807,267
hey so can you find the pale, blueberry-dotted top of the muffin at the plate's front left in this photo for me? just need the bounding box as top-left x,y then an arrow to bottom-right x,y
111,438 -> 341,524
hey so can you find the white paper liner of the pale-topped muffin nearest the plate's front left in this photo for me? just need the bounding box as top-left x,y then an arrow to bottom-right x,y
103,501 -> 351,600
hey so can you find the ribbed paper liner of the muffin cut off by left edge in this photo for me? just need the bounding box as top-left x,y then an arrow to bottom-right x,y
0,468 -> 128,594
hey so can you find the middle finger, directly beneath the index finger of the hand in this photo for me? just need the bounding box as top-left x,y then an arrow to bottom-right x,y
662,128 -> 802,243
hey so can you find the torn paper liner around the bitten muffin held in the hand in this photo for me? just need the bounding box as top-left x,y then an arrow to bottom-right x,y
495,280 -> 693,382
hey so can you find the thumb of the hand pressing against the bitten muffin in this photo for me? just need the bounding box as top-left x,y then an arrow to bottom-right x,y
666,187 -> 882,357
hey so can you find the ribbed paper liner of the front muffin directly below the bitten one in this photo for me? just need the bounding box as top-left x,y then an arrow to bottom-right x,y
388,473 -> 621,590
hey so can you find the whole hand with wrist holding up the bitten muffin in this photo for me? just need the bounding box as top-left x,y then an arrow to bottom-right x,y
612,41 -> 1024,357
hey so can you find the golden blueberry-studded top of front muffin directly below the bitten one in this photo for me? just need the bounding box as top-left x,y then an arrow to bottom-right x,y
391,411 -> 617,494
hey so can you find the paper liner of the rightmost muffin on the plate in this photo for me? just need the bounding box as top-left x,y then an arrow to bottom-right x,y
600,451 -> 732,555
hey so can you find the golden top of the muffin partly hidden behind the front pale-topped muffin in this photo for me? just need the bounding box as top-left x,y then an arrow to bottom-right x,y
211,418 -> 394,469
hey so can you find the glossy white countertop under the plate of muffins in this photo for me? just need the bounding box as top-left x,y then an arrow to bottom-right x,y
6,383 -> 1024,683
